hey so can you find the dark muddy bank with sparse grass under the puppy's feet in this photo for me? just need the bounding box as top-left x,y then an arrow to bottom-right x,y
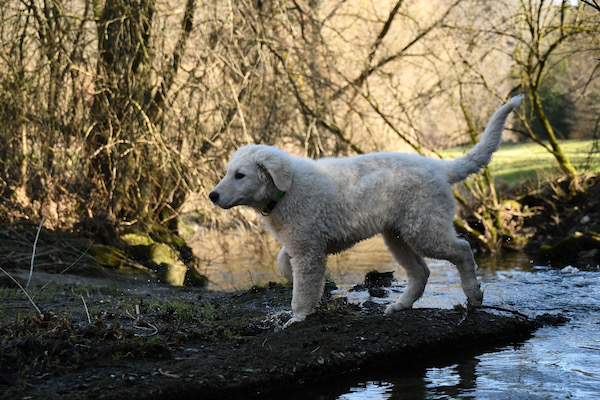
0,278 -> 561,399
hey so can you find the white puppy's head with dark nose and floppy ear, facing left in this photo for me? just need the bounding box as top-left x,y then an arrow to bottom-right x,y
209,145 -> 292,209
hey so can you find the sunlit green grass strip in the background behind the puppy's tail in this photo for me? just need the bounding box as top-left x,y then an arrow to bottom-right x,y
442,140 -> 600,186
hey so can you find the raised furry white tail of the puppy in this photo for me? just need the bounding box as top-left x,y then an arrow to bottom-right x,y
446,94 -> 523,184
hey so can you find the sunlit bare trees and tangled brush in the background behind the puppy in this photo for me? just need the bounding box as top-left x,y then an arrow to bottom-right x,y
0,0 -> 600,247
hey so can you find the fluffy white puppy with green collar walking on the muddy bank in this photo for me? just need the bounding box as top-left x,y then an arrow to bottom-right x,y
209,96 -> 522,323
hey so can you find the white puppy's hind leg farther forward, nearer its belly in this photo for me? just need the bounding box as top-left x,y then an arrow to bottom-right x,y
382,232 -> 429,314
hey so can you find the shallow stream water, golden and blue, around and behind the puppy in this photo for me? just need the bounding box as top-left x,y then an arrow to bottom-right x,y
193,233 -> 600,400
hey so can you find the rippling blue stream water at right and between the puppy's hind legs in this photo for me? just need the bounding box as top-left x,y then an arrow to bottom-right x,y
328,267 -> 600,400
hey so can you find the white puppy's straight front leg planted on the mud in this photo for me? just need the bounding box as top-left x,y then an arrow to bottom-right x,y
286,254 -> 327,326
